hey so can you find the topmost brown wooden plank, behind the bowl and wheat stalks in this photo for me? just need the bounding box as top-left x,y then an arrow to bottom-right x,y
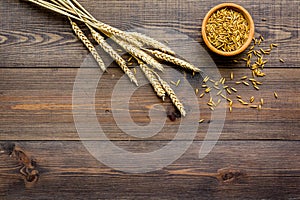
0,0 -> 300,67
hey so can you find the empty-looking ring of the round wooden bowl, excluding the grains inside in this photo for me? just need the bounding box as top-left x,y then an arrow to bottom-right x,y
202,3 -> 255,56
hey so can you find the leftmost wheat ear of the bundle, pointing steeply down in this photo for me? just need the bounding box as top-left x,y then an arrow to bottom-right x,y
69,18 -> 106,71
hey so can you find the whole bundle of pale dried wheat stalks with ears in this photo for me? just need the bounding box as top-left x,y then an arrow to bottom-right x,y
22,0 -> 200,116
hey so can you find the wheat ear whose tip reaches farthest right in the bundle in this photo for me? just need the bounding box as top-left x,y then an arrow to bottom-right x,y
146,49 -> 201,72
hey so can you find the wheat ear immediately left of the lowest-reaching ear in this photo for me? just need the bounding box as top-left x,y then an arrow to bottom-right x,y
138,61 -> 166,101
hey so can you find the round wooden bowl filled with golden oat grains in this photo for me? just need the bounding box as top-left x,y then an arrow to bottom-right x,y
202,3 -> 254,56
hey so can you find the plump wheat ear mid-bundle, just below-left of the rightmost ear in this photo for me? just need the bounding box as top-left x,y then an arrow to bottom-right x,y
112,37 -> 164,71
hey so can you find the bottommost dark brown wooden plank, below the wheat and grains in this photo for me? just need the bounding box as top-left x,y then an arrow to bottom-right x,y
0,141 -> 300,199
